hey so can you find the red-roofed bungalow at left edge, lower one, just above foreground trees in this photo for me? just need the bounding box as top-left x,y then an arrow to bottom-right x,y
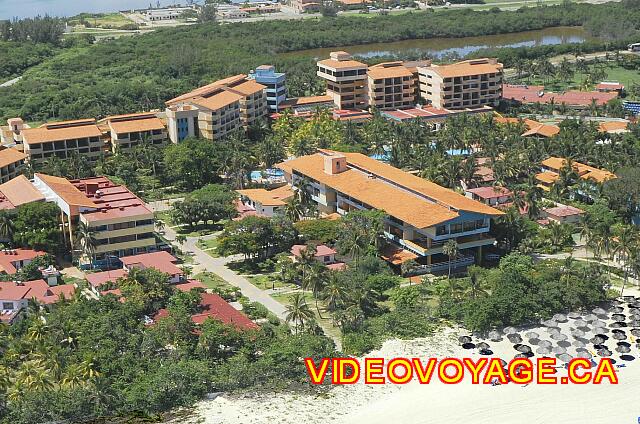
0,280 -> 76,324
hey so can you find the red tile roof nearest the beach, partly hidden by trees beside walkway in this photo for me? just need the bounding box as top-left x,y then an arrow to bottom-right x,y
151,293 -> 258,330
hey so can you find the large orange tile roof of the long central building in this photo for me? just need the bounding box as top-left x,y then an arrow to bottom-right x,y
278,151 -> 503,228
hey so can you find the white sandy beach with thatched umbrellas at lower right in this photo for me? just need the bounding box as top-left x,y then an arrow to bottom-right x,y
182,298 -> 640,424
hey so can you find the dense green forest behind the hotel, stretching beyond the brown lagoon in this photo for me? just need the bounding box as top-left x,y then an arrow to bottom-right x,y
0,1 -> 640,121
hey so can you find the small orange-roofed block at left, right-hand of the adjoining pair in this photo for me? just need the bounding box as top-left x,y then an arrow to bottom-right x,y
100,112 -> 169,153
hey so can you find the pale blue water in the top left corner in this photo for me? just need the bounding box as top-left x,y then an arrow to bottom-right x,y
0,0 -> 186,19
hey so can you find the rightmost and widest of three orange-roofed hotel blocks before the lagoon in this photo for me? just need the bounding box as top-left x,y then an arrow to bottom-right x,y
418,59 -> 502,110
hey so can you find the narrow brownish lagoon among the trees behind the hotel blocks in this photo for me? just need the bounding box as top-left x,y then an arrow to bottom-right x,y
286,27 -> 592,59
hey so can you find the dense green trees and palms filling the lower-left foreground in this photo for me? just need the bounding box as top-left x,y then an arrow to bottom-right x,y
0,269 -> 333,424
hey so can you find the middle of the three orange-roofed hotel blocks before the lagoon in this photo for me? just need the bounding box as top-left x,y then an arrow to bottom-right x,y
367,62 -> 417,110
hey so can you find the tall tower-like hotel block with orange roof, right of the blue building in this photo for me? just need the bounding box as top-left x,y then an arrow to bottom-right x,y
317,51 -> 367,109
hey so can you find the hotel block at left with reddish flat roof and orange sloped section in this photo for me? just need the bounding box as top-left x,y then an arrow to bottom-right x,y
33,173 -> 156,262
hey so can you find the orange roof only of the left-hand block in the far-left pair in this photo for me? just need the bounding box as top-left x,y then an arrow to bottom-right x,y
22,119 -> 102,144
